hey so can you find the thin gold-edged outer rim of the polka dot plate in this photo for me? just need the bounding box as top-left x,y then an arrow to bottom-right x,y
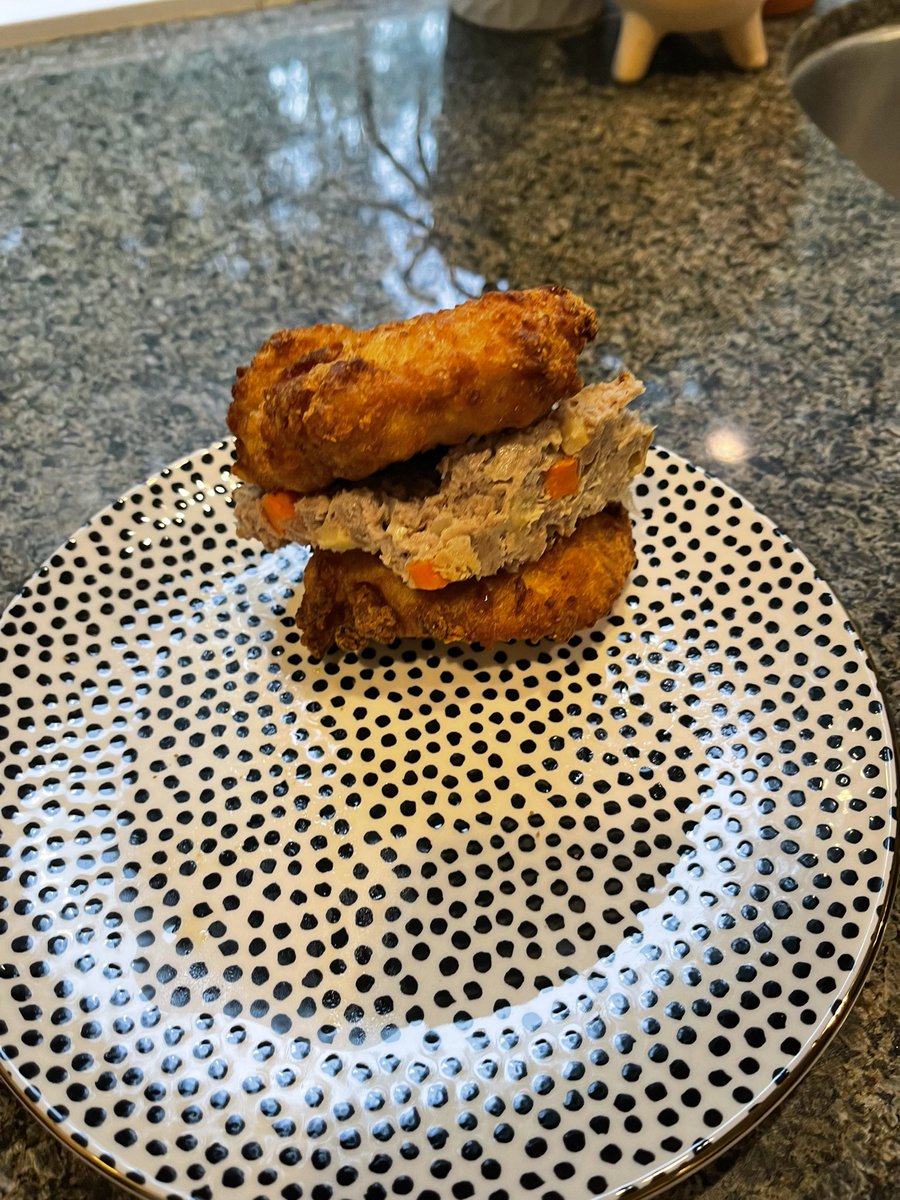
0,437 -> 900,1200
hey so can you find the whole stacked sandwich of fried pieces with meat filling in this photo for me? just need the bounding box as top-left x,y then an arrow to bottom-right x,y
228,287 -> 653,655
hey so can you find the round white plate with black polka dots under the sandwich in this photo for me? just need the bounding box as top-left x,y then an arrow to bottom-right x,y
0,445 -> 895,1200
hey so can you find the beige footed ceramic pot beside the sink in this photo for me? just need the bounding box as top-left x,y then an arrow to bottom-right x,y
612,0 -> 768,83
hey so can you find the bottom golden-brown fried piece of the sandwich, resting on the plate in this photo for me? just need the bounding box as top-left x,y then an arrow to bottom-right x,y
296,504 -> 635,655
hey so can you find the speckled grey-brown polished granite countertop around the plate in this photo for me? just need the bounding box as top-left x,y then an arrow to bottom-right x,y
0,0 -> 900,1200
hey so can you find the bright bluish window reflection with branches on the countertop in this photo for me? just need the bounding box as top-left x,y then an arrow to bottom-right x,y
266,8 -> 485,317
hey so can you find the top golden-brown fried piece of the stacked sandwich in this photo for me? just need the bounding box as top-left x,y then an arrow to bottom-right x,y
228,287 -> 598,493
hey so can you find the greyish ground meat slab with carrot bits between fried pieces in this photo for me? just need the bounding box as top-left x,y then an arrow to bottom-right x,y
235,374 -> 652,587
